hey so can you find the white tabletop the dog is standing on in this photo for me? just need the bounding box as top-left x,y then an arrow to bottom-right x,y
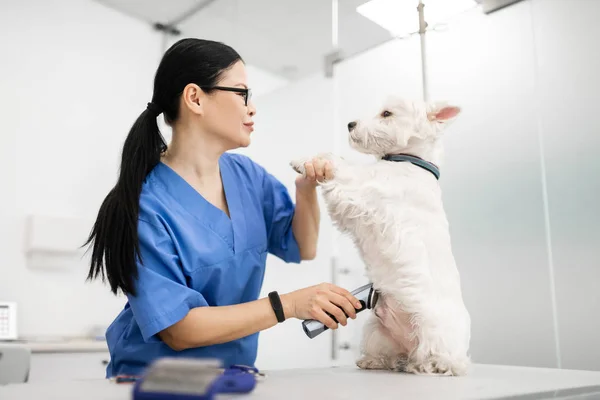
0,364 -> 600,400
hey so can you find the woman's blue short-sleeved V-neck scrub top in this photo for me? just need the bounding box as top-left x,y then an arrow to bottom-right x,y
106,153 -> 300,377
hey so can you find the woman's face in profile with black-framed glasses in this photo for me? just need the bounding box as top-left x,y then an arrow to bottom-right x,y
200,61 -> 256,148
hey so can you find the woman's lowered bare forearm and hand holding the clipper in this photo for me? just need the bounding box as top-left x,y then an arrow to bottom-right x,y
158,283 -> 361,351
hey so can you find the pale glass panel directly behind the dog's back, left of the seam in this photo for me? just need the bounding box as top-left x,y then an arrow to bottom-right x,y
427,2 -> 557,367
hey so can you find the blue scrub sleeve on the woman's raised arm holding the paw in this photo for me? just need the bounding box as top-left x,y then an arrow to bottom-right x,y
262,170 -> 301,263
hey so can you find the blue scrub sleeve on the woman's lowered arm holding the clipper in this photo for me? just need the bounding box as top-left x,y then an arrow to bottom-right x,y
127,220 -> 208,342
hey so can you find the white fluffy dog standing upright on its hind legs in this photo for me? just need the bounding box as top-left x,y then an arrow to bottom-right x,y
291,99 -> 471,375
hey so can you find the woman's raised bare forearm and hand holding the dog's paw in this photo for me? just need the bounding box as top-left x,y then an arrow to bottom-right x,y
292,159 -> 333,260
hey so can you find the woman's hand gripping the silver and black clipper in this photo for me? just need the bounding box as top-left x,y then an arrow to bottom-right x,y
281,283 -> 362,329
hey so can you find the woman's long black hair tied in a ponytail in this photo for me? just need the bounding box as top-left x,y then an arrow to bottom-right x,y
84,39 -> 243,295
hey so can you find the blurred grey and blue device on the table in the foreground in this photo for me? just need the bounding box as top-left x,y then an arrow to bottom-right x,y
133,357 -> 261,400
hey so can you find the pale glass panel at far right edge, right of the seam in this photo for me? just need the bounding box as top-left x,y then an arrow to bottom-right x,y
532,0 -> 600,370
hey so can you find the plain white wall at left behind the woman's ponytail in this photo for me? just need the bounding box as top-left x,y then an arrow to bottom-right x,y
0,0 -> 161,337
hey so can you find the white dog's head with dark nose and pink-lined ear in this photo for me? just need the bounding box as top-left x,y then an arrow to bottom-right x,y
348,98 -> 460,156
